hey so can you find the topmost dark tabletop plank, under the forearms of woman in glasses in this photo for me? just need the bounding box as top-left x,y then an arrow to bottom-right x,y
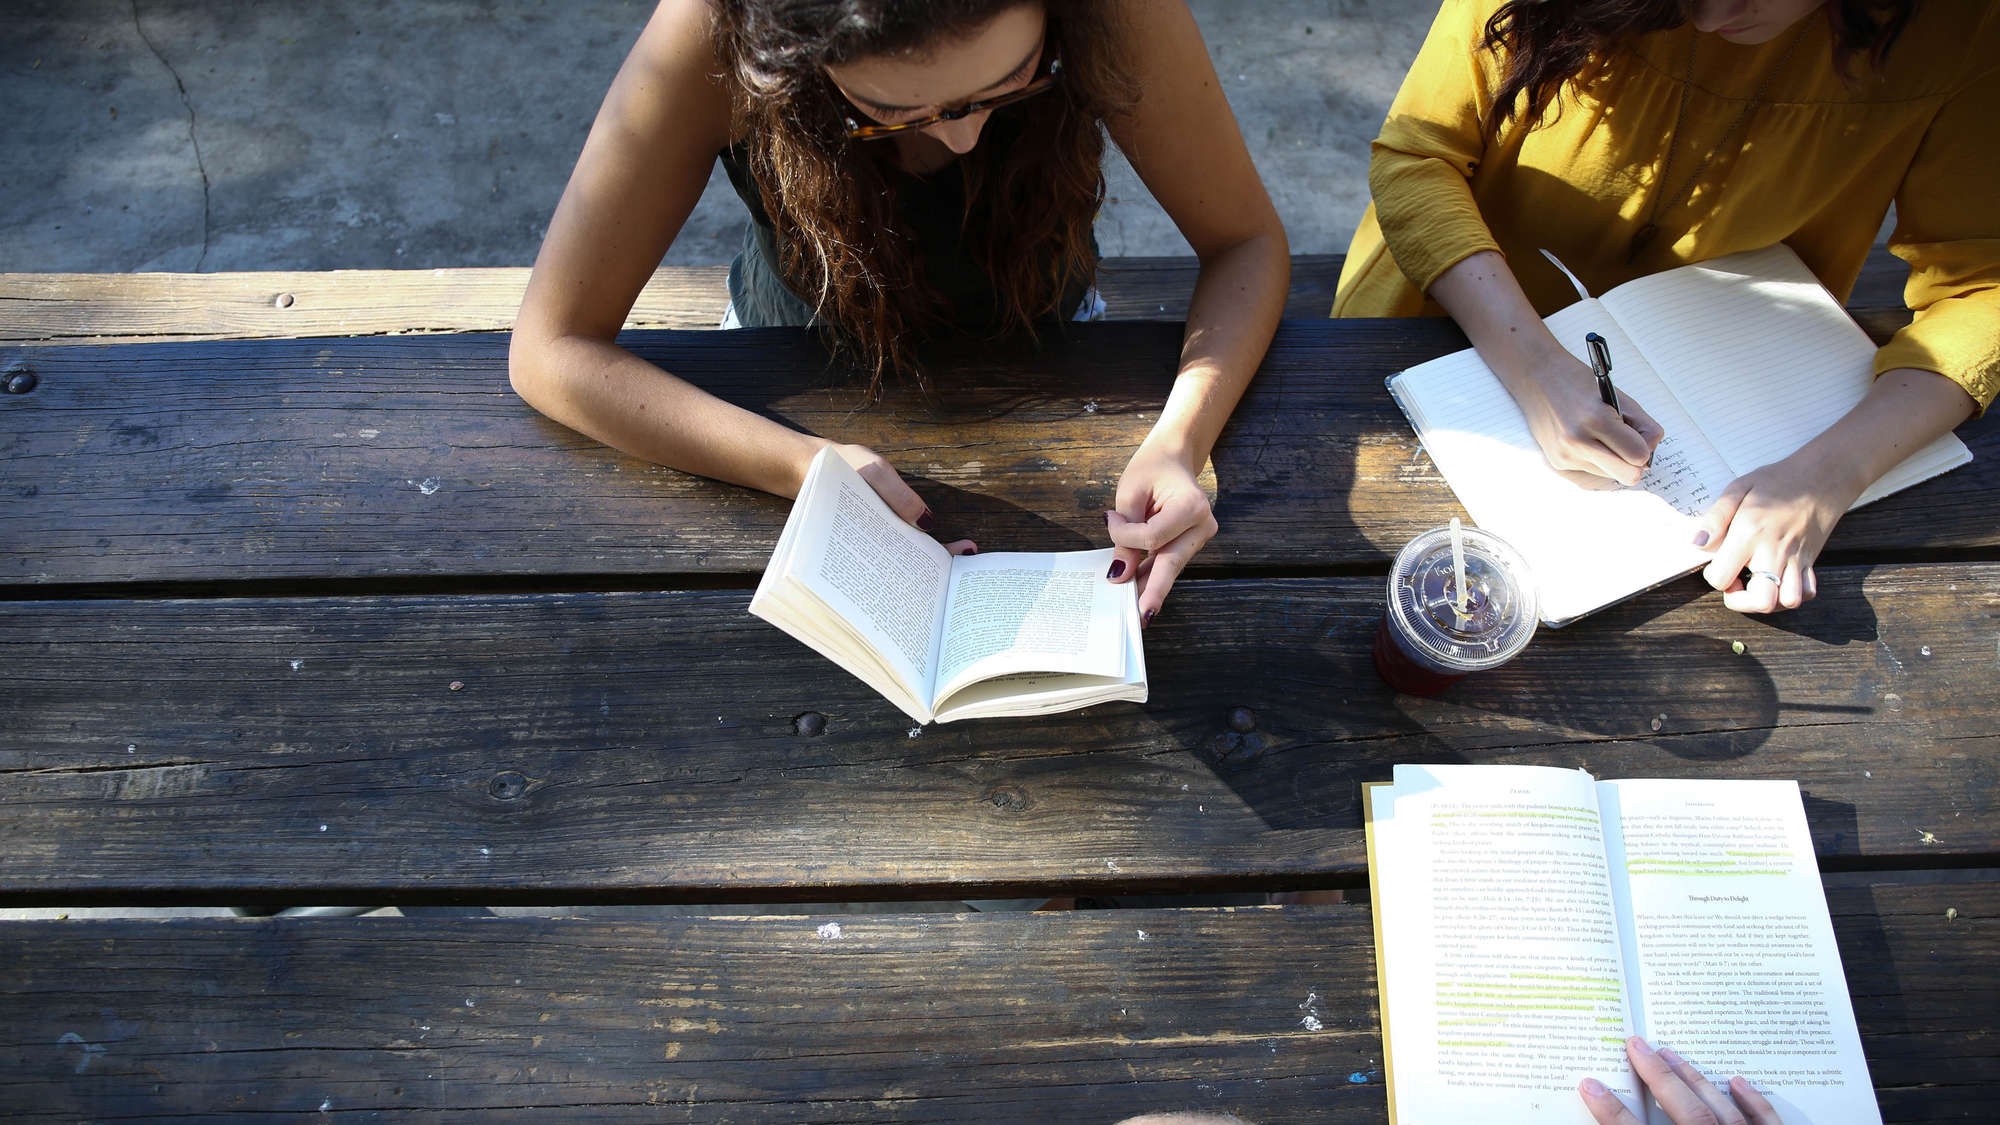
0,320 -> 2000,585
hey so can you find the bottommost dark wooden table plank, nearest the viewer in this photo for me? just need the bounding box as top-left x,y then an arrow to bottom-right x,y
0,875 -> 2000,1125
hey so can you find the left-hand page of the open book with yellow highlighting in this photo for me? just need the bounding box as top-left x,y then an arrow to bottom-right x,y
1370,765 -> 1638,1125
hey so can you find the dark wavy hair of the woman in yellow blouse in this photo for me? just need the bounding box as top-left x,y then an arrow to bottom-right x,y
1480,0 -> 1918,134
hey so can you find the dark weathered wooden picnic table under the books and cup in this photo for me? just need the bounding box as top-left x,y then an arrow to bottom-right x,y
0,260 -> 2000,1125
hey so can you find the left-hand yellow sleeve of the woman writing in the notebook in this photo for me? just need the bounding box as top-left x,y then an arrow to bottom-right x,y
1368,0 -> 1500,290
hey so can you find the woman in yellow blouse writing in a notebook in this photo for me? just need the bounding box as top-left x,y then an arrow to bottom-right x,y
1334,0 -> 2000,613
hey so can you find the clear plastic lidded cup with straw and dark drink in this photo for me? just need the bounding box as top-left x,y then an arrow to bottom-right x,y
1374,526 -> 1538,695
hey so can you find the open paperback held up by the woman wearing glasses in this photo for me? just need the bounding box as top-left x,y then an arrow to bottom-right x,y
750,448 -> 1146,723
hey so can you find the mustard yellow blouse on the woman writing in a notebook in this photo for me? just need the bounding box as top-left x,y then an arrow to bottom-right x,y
1334,0 -> 2000,410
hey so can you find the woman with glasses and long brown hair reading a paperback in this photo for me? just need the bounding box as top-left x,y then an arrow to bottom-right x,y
508,0 -> 1290,619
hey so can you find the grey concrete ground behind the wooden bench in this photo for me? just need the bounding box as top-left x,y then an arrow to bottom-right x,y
0,0 -> 1436,272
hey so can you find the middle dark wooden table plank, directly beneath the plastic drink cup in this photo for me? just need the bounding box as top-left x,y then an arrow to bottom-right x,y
0,565 -> 2000,905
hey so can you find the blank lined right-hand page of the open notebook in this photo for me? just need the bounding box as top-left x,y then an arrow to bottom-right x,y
1600,242 -> 1964,482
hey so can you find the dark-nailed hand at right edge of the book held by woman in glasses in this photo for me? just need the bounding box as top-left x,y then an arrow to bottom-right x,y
1104,440 -> 1216,623
